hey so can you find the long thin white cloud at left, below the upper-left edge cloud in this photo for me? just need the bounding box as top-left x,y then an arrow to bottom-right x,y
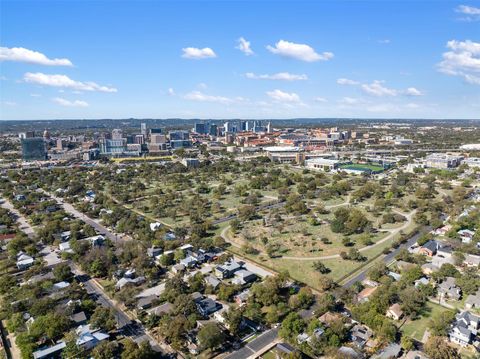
23,72 -> 117,92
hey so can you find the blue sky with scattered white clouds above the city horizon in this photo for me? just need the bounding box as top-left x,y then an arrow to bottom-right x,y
0,0 -> 480,120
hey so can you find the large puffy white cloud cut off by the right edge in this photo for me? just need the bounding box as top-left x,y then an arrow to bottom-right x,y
437,40 -> 480,85
